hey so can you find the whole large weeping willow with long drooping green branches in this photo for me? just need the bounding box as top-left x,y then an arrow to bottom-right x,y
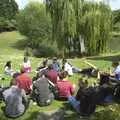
46,0 -> 111,54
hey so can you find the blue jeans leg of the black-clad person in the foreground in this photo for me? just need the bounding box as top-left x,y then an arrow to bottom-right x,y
68,96 -> 80,113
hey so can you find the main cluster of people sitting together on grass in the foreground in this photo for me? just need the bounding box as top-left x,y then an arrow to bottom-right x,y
0,58 -> 120,118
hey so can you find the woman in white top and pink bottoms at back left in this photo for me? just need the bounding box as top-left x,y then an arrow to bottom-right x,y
23,56 -> 31,73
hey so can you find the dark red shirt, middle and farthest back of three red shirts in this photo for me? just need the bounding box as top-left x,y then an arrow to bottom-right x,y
47,70 -> 57,84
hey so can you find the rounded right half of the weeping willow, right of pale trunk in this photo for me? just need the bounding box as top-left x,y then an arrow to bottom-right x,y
81,2 -> 112,54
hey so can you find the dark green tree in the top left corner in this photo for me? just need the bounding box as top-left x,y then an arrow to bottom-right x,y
0,0 -> 18,32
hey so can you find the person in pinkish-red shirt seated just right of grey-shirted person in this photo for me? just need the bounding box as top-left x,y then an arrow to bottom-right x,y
56,71 -> 75,100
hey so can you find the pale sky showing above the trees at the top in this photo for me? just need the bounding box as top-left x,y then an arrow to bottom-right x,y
15,0 -> 120,10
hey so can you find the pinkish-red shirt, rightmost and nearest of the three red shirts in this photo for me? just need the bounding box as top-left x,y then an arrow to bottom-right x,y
56,80 -> 75,98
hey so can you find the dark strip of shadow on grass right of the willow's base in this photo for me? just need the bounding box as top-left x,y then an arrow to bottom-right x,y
88,55 -> 120,61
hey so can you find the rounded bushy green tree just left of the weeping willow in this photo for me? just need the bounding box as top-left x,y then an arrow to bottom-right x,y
17,2 -> 52,48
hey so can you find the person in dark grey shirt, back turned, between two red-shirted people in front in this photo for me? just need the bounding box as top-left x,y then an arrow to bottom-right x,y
32,74 -> 54,106
